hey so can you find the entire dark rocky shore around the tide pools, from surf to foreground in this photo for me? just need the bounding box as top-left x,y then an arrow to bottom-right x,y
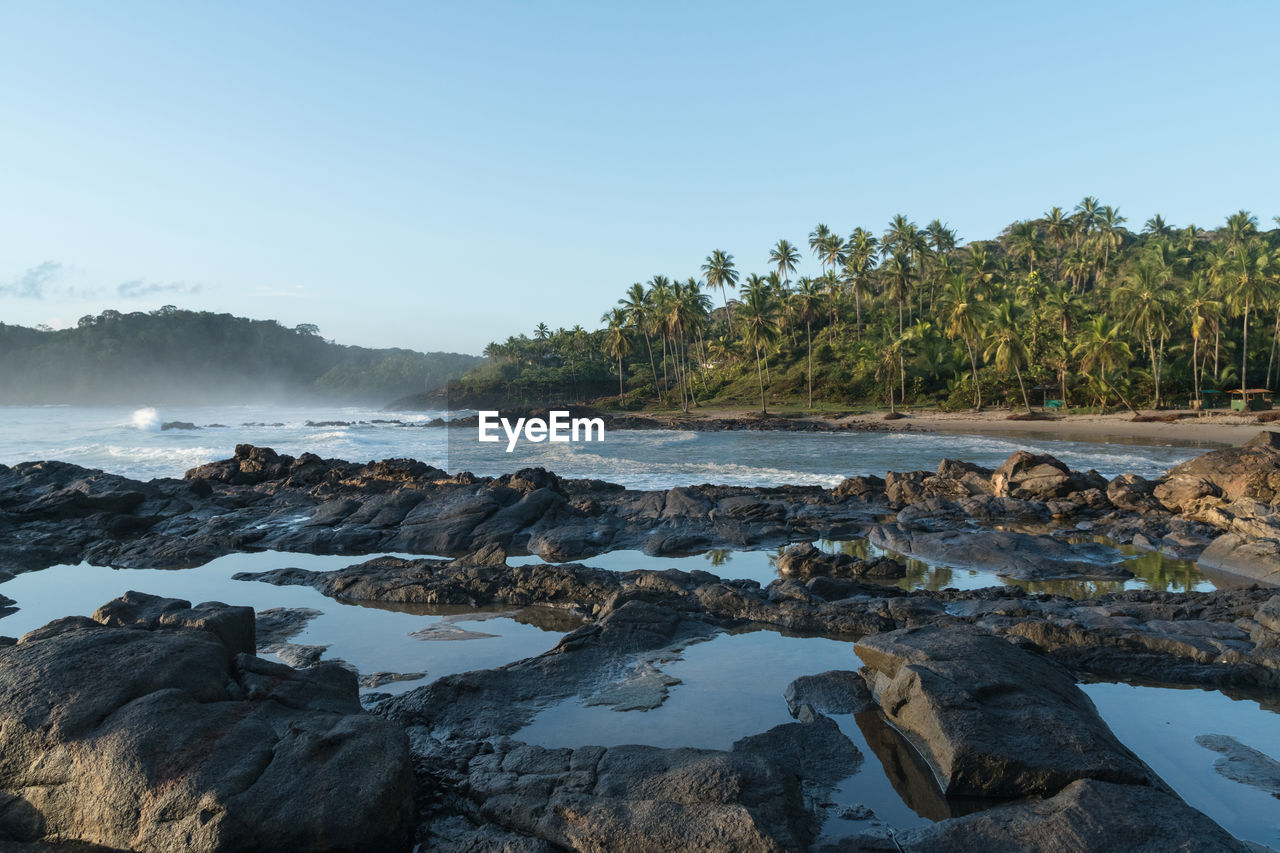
0,433 -> 1280,853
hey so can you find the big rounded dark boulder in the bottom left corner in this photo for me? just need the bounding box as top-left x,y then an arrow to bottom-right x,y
0,593 -> 413,850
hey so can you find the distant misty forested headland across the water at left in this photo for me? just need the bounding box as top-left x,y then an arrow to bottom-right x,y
0,306 -> 480,403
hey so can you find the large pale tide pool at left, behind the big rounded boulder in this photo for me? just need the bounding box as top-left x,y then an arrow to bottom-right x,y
0,551 -> 565,693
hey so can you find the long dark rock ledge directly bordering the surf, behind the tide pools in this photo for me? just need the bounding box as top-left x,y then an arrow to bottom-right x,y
0,444 -> 1249,571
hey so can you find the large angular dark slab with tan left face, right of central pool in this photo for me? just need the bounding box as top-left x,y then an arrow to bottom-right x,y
854,628 -> 1153,798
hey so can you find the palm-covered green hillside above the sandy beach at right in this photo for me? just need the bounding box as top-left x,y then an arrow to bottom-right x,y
452,197 -> 1280,410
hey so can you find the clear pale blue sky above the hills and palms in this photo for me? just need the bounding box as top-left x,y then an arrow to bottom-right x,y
0,0 -> 1280,352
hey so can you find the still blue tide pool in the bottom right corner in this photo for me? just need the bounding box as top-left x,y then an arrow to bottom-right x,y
1080,683 -> 1280,849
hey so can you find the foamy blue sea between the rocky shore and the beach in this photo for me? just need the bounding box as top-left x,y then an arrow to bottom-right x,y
0,406 -> 1204,489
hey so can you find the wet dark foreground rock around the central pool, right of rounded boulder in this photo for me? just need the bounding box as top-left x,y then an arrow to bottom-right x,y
227,560 -> 1280,850
